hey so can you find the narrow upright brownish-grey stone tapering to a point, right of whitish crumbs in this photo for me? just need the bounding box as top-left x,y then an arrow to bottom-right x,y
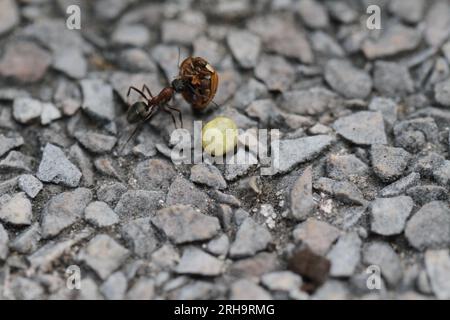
291,166 -> 316,221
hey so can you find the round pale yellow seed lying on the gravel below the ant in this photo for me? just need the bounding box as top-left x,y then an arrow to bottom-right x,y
202,117 -> 238,157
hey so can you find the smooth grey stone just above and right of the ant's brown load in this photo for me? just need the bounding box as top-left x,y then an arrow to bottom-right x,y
227,31 -> 261,68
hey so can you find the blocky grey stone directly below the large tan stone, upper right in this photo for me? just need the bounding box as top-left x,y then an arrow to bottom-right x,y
373,61 -> 414,97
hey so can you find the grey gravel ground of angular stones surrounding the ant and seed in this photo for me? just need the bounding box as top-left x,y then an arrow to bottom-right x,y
0,0 -> 450,299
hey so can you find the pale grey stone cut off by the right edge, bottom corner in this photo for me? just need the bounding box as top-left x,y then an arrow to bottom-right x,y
425,250 -> 450,300
